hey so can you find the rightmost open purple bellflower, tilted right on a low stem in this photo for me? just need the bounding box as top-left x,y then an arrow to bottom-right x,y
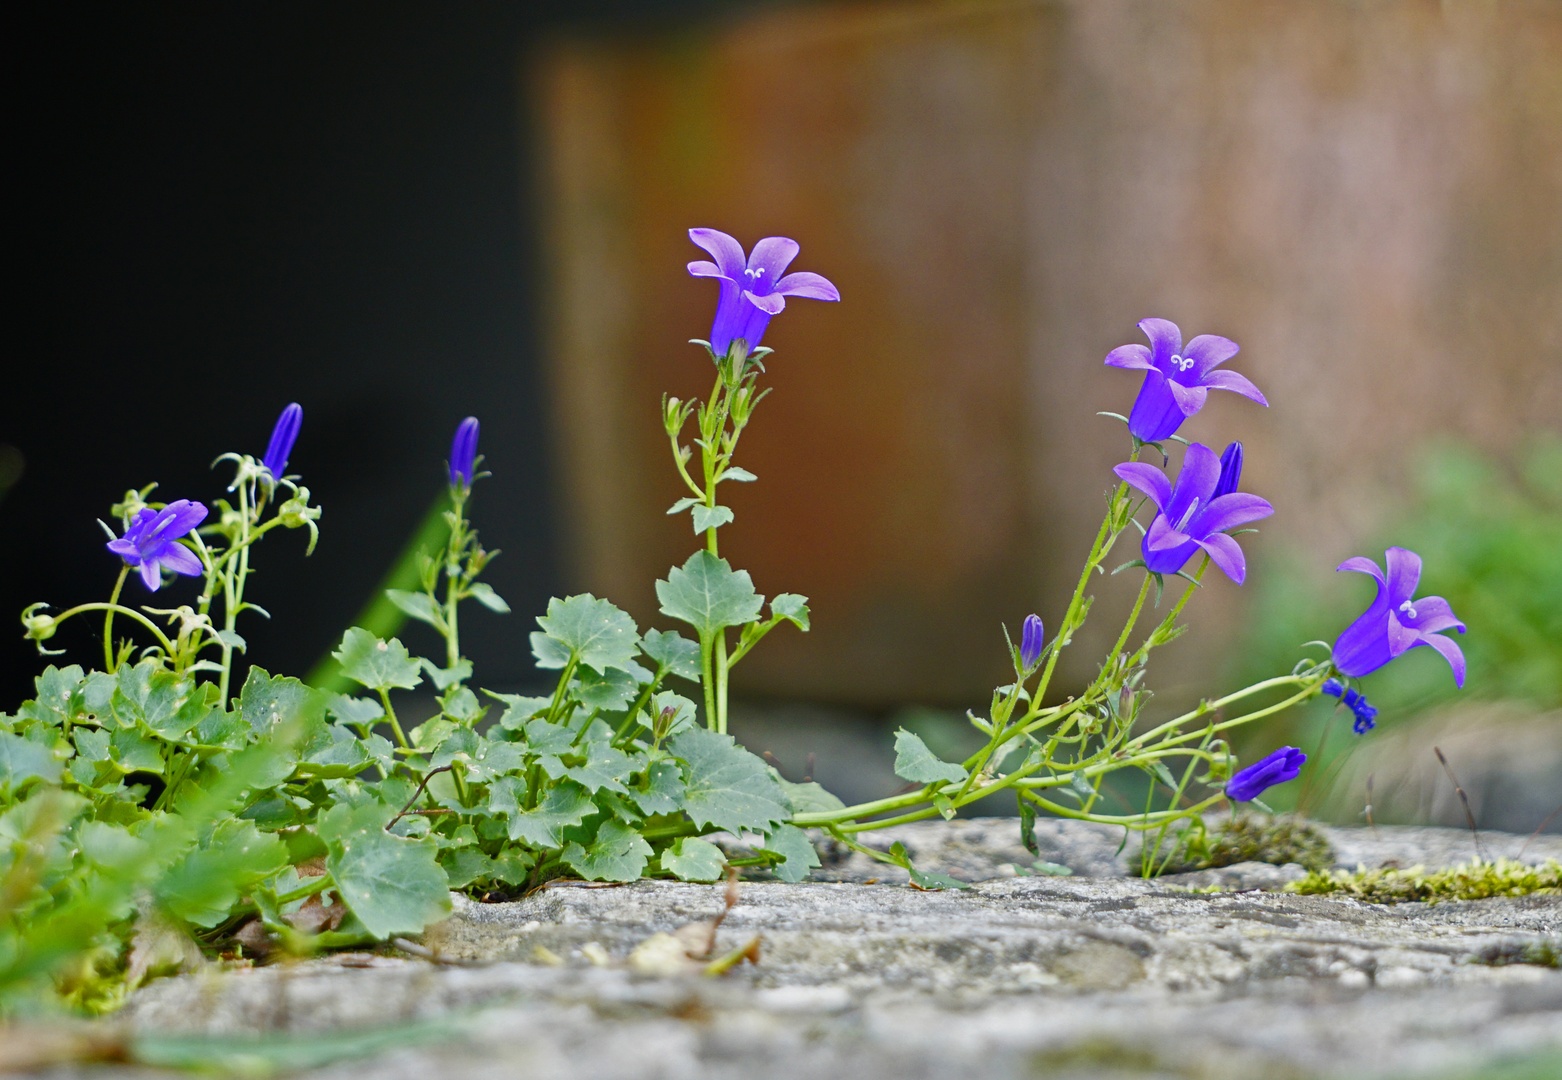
1334,547 -> 1465,688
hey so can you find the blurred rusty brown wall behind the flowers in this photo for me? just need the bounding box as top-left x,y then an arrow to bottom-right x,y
533,0 -> 1562,703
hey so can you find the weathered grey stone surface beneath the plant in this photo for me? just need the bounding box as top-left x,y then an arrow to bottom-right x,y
79,821 -> 1562,1080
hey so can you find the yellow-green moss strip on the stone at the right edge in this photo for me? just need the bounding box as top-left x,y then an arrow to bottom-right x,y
1286,858 -> 1562,906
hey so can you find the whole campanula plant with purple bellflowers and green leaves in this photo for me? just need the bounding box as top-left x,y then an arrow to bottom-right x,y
0,228 -> 1464,1008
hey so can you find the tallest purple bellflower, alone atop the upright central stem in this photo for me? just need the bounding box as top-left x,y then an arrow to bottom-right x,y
689,228 -> 840,356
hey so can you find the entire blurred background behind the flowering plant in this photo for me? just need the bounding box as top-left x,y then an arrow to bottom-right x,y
0,0 -> 1562,831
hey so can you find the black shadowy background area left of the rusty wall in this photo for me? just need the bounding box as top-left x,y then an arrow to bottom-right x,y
0,3 -> 734,708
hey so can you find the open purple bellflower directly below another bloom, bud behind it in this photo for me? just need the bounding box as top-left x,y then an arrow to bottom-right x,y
1112,442 -> 1275,585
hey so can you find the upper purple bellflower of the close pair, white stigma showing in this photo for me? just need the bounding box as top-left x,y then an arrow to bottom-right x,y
1106,319 -> 1268,442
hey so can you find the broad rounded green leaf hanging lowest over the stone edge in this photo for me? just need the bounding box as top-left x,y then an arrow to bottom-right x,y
319,803 -> 450,938
